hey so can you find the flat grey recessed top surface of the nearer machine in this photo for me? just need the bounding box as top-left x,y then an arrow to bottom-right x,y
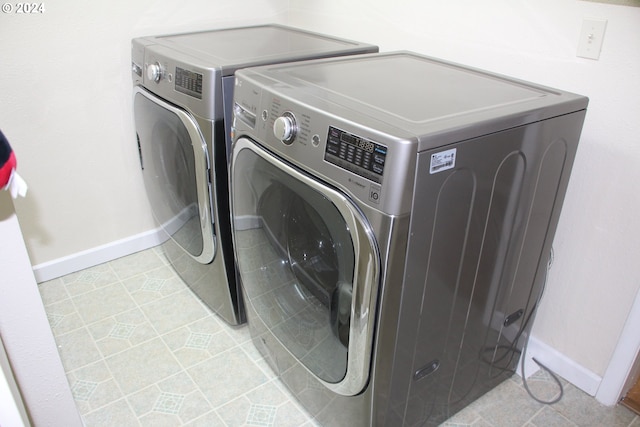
285,55 -> 547,122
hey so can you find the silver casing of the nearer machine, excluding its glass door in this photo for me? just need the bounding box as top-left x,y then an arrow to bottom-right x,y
231,52 -> 588,426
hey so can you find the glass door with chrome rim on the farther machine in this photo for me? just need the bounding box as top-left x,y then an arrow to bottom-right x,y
134,87 -> 216,264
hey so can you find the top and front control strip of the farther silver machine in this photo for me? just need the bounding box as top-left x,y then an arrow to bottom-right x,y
132,24 -> 378,119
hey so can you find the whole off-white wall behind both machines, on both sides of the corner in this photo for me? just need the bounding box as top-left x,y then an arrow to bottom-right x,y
0,0 -> 640,412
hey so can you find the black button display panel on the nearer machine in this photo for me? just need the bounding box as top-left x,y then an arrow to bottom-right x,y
324,126 -> 387,184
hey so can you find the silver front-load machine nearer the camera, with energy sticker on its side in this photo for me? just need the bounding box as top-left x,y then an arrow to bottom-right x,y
231,52 -> 588,426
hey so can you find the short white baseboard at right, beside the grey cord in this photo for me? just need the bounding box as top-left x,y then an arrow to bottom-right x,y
518,336 -> 602,396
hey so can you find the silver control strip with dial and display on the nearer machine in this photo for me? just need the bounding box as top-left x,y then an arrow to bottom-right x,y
233,77 -> 418,216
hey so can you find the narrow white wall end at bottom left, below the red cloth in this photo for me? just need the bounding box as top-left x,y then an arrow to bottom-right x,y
0,191 -> 82,427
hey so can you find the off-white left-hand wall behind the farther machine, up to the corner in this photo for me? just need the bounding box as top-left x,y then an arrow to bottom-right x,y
0,0 -> 287,272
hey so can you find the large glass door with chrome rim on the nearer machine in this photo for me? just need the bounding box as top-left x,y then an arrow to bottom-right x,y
231,138 -> 380,395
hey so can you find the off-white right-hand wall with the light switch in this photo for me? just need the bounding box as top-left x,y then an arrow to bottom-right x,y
289,0 -> 640,402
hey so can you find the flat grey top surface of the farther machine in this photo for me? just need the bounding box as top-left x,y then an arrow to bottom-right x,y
146,24 -> 378,75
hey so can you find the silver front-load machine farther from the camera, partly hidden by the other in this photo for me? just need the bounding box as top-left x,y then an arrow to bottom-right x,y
132,25 -> 378,325
